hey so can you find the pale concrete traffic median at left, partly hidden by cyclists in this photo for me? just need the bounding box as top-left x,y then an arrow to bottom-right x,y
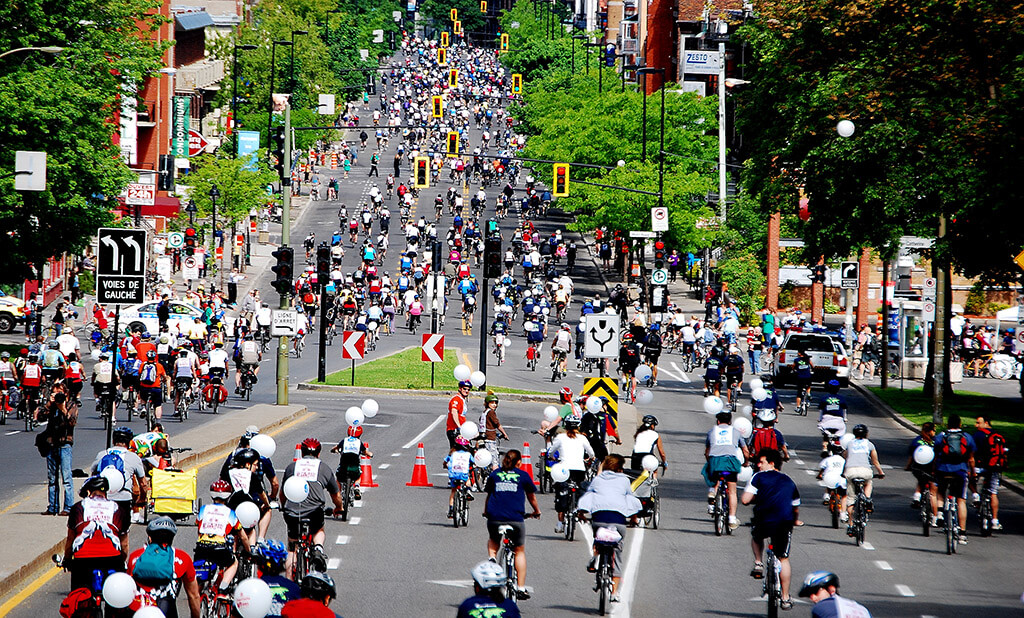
0,404 -> 311,598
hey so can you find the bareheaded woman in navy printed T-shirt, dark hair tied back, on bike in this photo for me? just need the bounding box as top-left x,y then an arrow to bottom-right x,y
483,448 -> 541,600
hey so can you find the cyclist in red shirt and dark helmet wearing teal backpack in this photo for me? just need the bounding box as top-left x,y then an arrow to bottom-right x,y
128,516 -> 201,618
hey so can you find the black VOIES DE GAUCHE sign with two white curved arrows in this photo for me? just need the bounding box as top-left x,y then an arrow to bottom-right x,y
96,227 -> 146,305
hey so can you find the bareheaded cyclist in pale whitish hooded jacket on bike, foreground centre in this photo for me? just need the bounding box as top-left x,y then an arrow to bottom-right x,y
580,453 -> 643,603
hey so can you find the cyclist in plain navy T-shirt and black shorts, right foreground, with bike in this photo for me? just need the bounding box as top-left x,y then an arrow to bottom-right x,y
740,448 -> 804,610
